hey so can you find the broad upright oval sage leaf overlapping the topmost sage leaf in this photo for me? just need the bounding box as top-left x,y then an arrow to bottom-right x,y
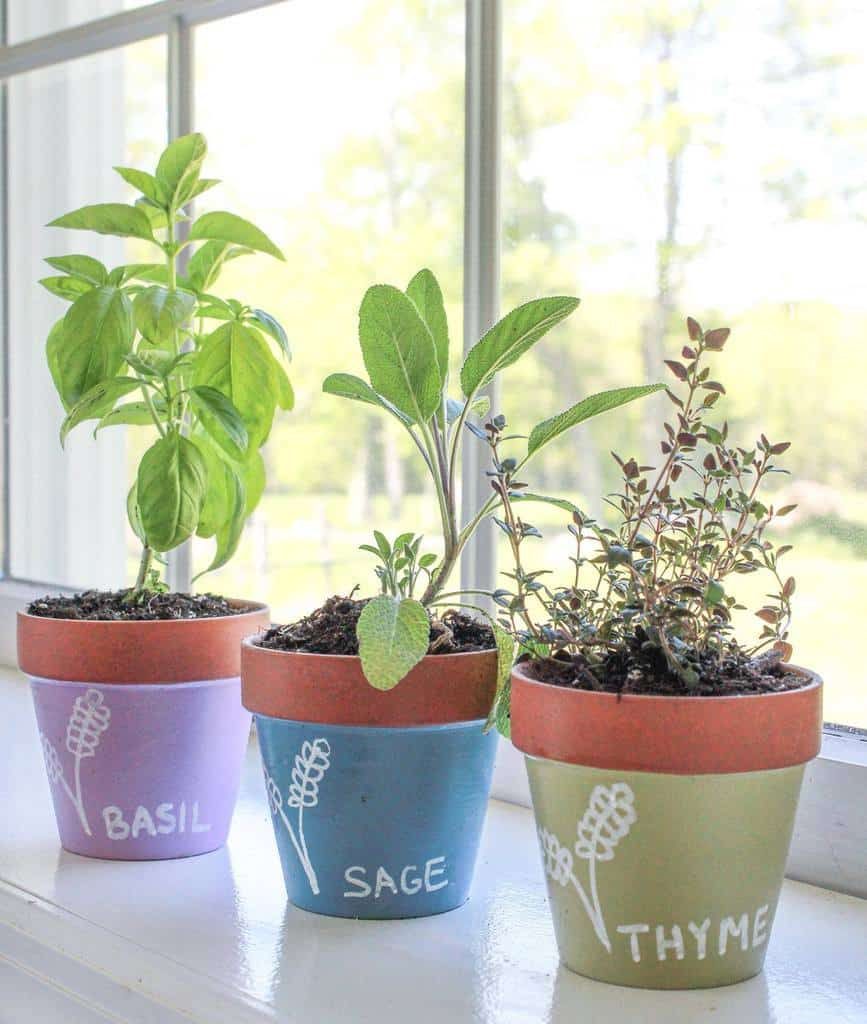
358,285 -> 442,423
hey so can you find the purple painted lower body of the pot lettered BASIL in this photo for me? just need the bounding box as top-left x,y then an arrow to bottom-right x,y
31,678 -> 250,860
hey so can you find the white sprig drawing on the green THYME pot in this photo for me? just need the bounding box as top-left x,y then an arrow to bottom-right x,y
538,782 -> 638,953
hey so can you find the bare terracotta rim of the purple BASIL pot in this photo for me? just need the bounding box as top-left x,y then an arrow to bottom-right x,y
17,599 -> 270,684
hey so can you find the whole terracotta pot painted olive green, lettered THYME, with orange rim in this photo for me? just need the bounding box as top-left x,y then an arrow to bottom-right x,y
512,667 -> 822,988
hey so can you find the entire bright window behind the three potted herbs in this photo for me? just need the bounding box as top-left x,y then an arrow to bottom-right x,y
0,0 -> 867,897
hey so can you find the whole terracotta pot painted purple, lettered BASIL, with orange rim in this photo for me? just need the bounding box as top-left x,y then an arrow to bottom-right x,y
18,602 -> 269,860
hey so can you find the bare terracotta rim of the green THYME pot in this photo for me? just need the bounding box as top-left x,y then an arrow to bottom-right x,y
512,666 -> 823,775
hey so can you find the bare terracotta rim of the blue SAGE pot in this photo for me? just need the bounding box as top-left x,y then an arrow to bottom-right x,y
241,637 -> 496,728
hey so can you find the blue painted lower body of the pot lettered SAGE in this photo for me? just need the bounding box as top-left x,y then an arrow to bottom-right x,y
255,714 -> 496,920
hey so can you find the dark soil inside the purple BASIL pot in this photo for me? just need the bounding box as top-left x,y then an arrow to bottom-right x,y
27,590 -> 250,622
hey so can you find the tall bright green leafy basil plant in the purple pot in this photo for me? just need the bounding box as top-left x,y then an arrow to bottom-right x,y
41,134 -> 294,595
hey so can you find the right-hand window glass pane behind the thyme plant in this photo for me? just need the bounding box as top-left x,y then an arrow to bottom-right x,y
503,0 -> 867,726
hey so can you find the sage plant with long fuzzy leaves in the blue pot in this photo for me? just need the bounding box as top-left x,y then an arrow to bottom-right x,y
322,269 -> 659,689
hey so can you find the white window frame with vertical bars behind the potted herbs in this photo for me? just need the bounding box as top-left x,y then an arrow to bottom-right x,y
0,0 -> 867,897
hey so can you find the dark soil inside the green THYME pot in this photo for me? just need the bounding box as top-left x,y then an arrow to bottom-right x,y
523,630 -> 810,697
